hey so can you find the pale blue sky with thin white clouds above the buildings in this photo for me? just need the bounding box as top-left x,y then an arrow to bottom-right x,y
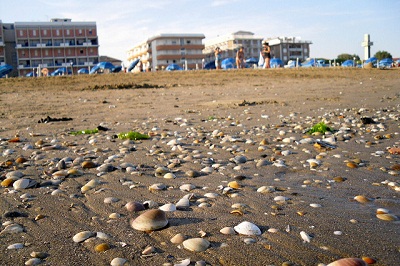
0,0 -> 400,60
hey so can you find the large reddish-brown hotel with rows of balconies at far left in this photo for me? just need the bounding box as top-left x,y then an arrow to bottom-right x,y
0,19 -> 99,76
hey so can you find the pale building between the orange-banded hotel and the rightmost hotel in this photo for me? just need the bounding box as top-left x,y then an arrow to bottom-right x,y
203,31 -> 263,63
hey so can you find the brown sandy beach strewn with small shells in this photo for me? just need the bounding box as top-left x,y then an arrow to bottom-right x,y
0,69 -> 400,265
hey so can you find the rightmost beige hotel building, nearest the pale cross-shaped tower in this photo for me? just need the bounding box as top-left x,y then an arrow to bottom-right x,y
264,37 -> 312,64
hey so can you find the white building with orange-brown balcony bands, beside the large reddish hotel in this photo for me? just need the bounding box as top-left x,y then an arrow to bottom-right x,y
127,33 -> 205,70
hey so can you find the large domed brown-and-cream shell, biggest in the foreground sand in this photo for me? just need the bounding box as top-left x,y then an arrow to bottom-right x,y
131,209 -> 168,231
